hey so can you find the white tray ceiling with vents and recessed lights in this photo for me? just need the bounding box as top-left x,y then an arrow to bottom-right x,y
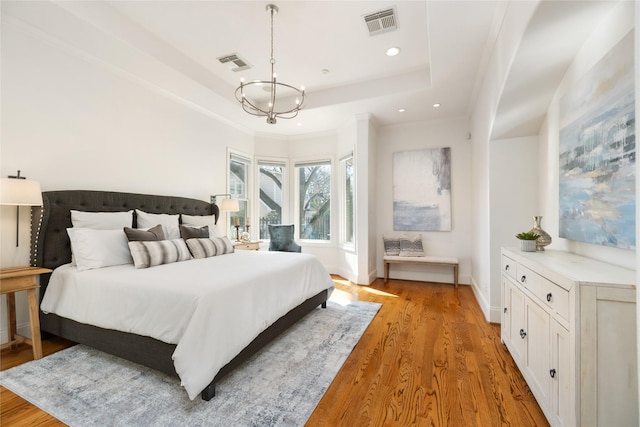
48,0 -> 504,135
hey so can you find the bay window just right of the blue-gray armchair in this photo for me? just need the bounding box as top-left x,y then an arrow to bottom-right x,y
295,160 -> 331,241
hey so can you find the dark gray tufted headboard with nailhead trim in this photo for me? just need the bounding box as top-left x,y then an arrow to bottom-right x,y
31,190 -> 220,274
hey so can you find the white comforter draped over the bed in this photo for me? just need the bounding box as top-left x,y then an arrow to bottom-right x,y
41,251 -> 334,399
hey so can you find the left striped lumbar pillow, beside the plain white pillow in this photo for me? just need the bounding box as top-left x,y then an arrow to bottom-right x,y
129,239 -> 191,268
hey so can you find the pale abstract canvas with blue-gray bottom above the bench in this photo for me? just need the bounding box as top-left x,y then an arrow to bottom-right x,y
393,147 -> 451,231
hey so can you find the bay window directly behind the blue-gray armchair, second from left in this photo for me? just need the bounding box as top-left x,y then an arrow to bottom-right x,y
258,160 -> 287,239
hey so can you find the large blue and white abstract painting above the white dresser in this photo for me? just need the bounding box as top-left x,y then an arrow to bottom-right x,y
559,31 -> 636,249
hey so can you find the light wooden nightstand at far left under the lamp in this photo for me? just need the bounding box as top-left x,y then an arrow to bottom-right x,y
0,267 -> 51,360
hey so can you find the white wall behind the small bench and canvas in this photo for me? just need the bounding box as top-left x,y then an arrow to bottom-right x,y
375,117 -> 474,284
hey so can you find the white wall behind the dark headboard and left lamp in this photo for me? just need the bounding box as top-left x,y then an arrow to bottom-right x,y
0,8 -> 253,341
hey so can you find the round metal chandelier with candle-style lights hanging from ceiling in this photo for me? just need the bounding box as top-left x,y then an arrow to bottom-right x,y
236,4 -> 305,125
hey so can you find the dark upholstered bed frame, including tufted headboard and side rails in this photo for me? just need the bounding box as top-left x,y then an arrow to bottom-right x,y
31,190 -> 328,400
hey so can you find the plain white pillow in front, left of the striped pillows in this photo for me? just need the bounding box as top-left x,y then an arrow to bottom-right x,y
67,227 -> 133,271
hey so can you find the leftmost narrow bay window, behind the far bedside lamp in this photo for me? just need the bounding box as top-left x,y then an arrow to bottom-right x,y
229,153 -> 251,238
